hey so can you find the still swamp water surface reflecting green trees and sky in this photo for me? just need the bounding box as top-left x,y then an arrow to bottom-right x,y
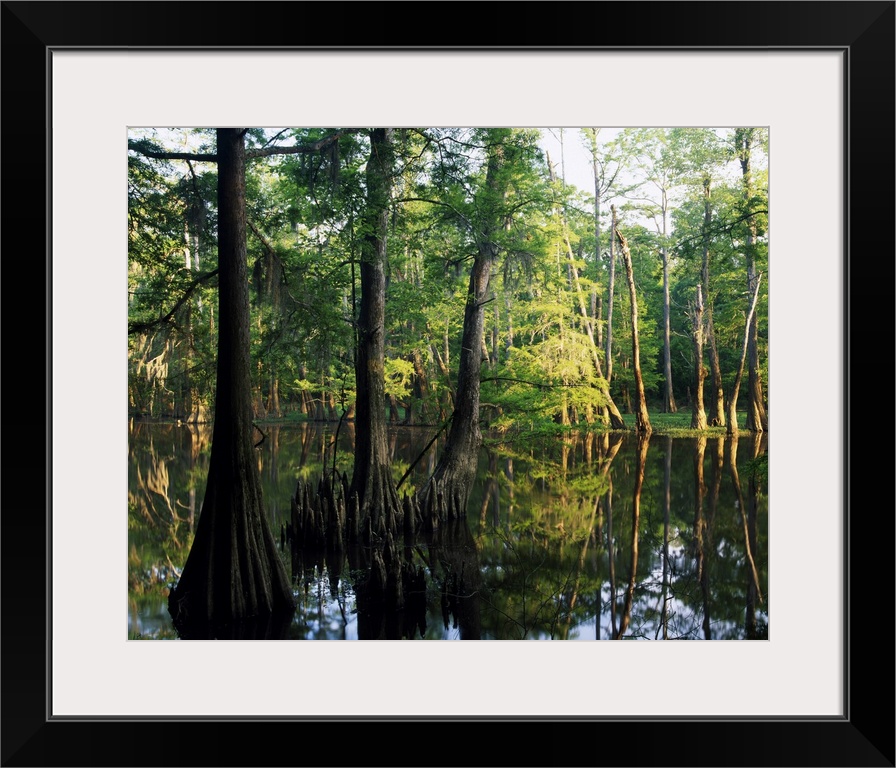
128,422 -> 768,640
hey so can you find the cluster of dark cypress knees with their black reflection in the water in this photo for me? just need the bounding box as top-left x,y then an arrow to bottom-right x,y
281,473 -> 481,639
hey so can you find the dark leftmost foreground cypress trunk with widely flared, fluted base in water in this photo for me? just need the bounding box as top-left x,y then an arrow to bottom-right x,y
168,128 -> 295,637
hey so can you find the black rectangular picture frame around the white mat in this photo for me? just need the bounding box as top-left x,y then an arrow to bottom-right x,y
0,0 -> 896,766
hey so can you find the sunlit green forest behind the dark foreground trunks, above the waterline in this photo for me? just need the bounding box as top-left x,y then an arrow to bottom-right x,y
128,128 -> 768,432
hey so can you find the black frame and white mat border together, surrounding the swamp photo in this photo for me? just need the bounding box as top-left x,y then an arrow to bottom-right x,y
2,1 -> 896,766
